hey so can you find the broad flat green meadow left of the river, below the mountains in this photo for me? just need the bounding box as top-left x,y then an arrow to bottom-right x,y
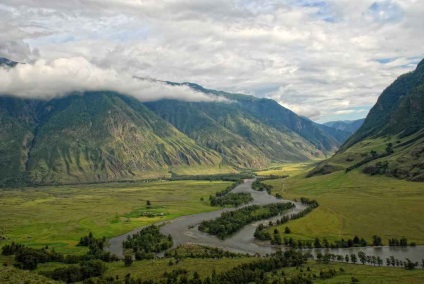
0,181 -> 231,253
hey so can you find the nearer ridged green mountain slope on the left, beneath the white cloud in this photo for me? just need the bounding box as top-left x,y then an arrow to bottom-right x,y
0,92 -> 222,185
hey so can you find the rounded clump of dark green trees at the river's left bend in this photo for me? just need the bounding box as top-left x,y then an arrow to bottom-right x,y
123,225 -> 173,260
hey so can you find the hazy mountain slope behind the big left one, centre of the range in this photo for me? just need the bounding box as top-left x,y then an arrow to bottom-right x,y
146,100 -> 322,168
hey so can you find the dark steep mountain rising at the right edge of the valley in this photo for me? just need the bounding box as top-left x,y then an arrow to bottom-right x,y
310,60 -> 424,181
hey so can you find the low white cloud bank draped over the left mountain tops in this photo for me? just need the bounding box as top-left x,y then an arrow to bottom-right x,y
0,57 -> 225,102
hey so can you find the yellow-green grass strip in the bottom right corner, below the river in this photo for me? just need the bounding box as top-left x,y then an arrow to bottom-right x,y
273,261 -> 424,284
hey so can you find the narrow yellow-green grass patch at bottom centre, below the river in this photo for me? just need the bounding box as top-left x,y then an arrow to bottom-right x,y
106,257 -> 257,280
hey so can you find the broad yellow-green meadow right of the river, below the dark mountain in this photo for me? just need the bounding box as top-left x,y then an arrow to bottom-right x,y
266,166 -> 424,244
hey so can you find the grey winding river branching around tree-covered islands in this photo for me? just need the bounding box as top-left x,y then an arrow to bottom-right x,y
107,179 -> 424,263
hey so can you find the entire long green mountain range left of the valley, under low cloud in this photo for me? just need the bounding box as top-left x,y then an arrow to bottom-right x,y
0,58 -> 349,187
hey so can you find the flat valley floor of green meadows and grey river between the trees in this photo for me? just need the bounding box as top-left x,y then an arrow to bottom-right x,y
0,163 -> 424,283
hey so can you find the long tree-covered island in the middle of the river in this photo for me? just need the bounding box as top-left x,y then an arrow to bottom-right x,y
199,202 -> 294,239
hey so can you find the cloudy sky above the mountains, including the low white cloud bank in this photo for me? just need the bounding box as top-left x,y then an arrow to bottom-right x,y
0,0 -> 424,122
